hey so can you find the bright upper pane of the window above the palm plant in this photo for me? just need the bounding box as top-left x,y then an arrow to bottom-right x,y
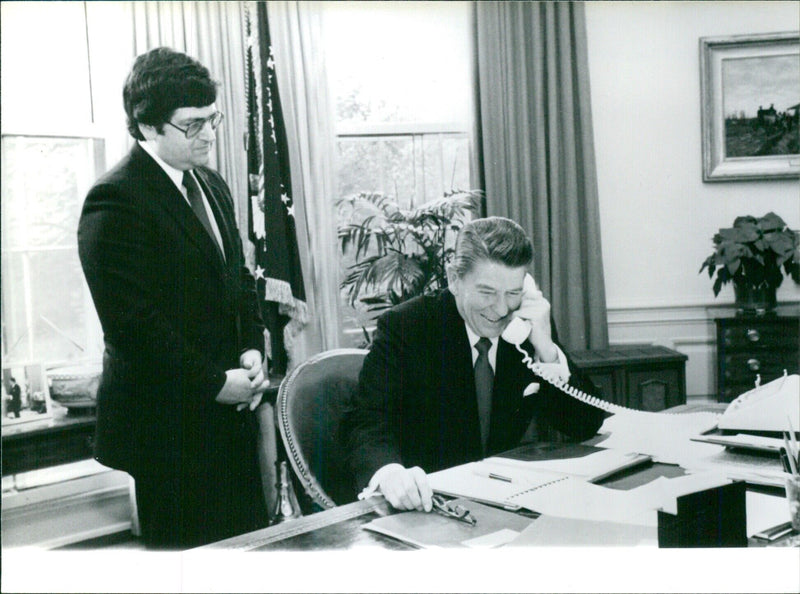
325,2 -> 472,123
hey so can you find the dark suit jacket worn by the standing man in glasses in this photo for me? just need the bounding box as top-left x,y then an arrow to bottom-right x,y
78,144 -> 264,481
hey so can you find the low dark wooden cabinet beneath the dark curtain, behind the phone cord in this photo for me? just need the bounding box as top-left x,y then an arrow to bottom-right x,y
570,346 -> 688,411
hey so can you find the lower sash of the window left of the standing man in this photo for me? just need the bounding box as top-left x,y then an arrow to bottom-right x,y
2,135 -> 103,365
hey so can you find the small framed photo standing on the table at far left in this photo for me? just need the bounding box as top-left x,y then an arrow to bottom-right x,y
0,363 -> 53,429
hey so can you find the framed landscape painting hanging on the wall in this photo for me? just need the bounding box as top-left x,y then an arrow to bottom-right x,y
700,31 -> 800,182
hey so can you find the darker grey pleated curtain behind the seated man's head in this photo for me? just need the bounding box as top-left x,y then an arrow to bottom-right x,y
475,2 -> 608,349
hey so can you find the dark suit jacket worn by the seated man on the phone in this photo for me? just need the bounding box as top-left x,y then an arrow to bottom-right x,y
344,290 -> 604,489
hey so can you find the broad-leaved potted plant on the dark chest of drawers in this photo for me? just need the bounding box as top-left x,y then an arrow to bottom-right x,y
700,212 -> 800,313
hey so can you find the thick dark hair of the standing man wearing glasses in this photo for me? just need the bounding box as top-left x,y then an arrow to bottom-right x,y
122,47 -> 218,140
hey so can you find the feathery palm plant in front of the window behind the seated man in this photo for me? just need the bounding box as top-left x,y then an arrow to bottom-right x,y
336,190 -> 482,338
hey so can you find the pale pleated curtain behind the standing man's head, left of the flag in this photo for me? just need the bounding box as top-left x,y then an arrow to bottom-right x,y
126,2 -> 253,246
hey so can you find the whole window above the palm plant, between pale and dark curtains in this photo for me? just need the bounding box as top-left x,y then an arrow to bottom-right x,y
325,2 -> 477,344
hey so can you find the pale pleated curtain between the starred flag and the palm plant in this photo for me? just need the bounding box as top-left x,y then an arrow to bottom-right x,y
266,1 -> 341,369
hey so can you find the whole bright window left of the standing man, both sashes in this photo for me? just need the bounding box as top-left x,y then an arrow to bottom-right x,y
0,2 -> 104,367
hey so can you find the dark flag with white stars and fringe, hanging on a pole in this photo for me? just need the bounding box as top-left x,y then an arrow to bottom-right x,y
245,2 -> 308,374
